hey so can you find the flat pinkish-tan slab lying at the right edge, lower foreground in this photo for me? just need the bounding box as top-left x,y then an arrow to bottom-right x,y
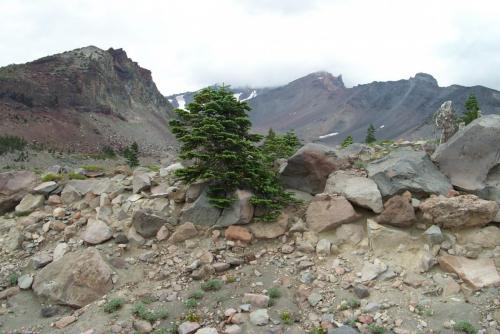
438,255 -> 500,289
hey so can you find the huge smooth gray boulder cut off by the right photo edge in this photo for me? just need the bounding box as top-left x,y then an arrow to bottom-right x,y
432,115 -> 500,202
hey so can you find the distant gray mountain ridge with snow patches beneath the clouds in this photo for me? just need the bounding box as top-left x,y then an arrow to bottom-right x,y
171,72 -> 500,143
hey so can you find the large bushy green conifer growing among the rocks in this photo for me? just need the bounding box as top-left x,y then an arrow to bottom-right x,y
170,86 -> 292,219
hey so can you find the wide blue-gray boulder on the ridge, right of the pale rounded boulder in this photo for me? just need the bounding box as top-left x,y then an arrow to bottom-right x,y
367,148 -> 452,198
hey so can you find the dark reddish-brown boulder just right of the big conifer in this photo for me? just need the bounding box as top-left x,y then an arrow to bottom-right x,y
280,143 -> 350,194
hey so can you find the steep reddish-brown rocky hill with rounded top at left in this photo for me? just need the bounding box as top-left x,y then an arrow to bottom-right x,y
0,46 -> 173,151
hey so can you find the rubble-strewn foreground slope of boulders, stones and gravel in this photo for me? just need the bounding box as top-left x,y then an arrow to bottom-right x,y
0,116 -> 500,334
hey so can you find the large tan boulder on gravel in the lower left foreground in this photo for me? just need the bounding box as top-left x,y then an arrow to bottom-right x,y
32,248 -> 113,307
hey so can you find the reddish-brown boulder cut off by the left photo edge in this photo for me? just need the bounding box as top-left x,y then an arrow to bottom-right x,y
0,171 -> 38,215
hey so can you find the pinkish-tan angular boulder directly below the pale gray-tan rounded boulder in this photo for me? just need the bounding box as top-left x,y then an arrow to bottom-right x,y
306,194 -> 360,232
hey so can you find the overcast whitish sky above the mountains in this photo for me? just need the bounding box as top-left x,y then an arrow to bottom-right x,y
0,0 -> 500,94
